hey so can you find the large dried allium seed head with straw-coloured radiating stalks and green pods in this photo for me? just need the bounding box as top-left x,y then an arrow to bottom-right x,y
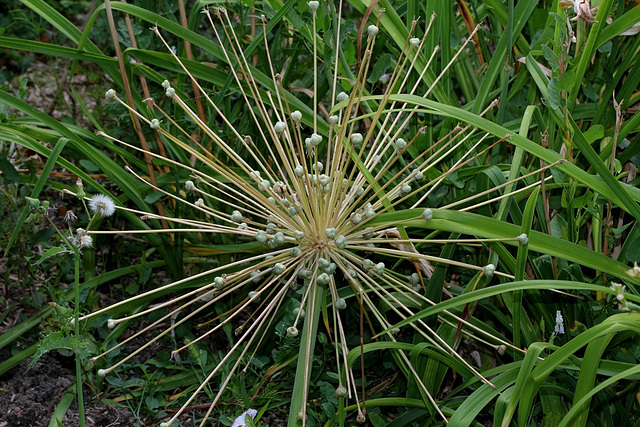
80,1 -> 554,426
